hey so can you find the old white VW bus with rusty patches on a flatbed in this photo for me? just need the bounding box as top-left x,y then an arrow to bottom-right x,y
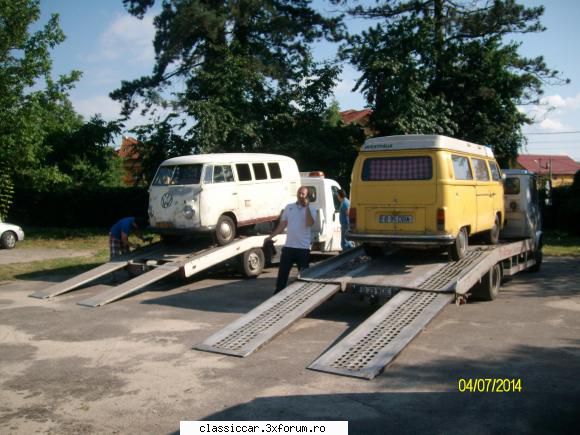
149,153 -> 300,245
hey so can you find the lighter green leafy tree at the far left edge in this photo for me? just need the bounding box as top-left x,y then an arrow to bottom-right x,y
0,0 -> 82,188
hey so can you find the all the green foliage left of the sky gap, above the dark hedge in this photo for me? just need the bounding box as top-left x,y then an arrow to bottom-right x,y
0,0 -> 121,196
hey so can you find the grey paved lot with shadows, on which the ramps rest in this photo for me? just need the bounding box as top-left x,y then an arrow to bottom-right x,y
0,258 -> 580,434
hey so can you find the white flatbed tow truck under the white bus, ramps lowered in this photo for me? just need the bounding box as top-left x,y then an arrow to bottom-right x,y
30,171 -> 340,308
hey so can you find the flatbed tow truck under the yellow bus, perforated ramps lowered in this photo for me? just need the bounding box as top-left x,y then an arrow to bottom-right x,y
194,171 -> 542,379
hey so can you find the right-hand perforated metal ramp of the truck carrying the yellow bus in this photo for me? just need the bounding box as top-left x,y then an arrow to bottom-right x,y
308,290 -> 453,379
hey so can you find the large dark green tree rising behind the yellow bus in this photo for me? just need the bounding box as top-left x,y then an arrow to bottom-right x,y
338,0 -> 564,163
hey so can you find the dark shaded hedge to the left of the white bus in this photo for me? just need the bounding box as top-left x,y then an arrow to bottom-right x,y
9,187 -> 148,228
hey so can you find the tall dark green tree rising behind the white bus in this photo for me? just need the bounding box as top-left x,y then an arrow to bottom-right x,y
111,0 -> 342,155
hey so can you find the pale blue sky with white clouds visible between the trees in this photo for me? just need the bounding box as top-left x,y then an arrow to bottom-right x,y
37,0 -> 580,161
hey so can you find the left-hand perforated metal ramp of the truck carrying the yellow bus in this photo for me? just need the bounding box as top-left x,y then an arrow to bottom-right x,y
193,282 -> 340,357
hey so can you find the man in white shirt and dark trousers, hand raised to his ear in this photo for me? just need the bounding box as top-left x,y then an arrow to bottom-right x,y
266,186 -> 316,294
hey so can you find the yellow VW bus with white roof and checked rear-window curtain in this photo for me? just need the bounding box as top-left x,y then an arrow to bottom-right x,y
347,135 -> 504,260
